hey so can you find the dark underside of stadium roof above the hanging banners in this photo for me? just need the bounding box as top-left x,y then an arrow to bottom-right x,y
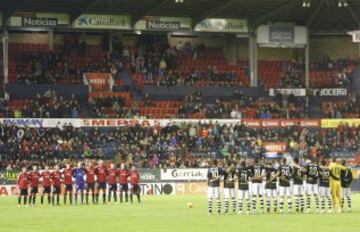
0,0 -> 360,32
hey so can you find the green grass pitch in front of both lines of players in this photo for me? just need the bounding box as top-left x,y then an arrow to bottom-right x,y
0,194 -> 360,232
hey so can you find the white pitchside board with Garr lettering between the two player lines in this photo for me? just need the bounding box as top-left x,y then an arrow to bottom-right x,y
160,168 -> 208,181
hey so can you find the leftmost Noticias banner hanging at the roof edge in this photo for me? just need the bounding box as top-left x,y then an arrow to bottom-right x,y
8,12 -> 70,27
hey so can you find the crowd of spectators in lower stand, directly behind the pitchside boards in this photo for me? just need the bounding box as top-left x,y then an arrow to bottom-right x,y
0,121 -> 360,168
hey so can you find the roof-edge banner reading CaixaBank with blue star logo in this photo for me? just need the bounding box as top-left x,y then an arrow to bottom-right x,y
73,14 -> 131,30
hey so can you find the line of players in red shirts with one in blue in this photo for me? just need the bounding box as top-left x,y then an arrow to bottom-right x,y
17,161 -> 141,207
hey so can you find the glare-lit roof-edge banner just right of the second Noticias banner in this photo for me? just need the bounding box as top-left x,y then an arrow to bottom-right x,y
194,18 -> 249,33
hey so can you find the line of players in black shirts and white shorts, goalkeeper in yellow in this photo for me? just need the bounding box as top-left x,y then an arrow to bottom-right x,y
208,158 -> 353,214
